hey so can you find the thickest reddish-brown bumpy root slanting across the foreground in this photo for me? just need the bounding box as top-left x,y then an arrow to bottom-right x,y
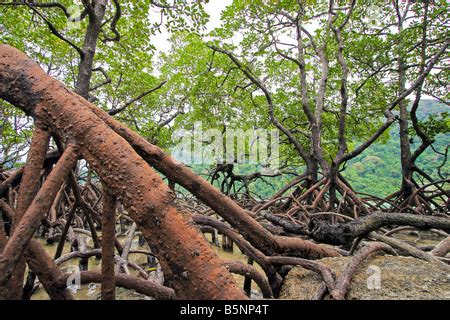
0,45 -> 246,299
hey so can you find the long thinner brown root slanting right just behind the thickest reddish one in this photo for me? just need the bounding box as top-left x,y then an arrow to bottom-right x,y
83,91 -> 339,258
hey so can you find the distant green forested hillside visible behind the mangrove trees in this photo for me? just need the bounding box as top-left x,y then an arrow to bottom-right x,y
185,100 -> 450,198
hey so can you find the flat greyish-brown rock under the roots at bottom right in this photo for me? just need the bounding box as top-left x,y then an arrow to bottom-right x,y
280,255 -> 450,300
